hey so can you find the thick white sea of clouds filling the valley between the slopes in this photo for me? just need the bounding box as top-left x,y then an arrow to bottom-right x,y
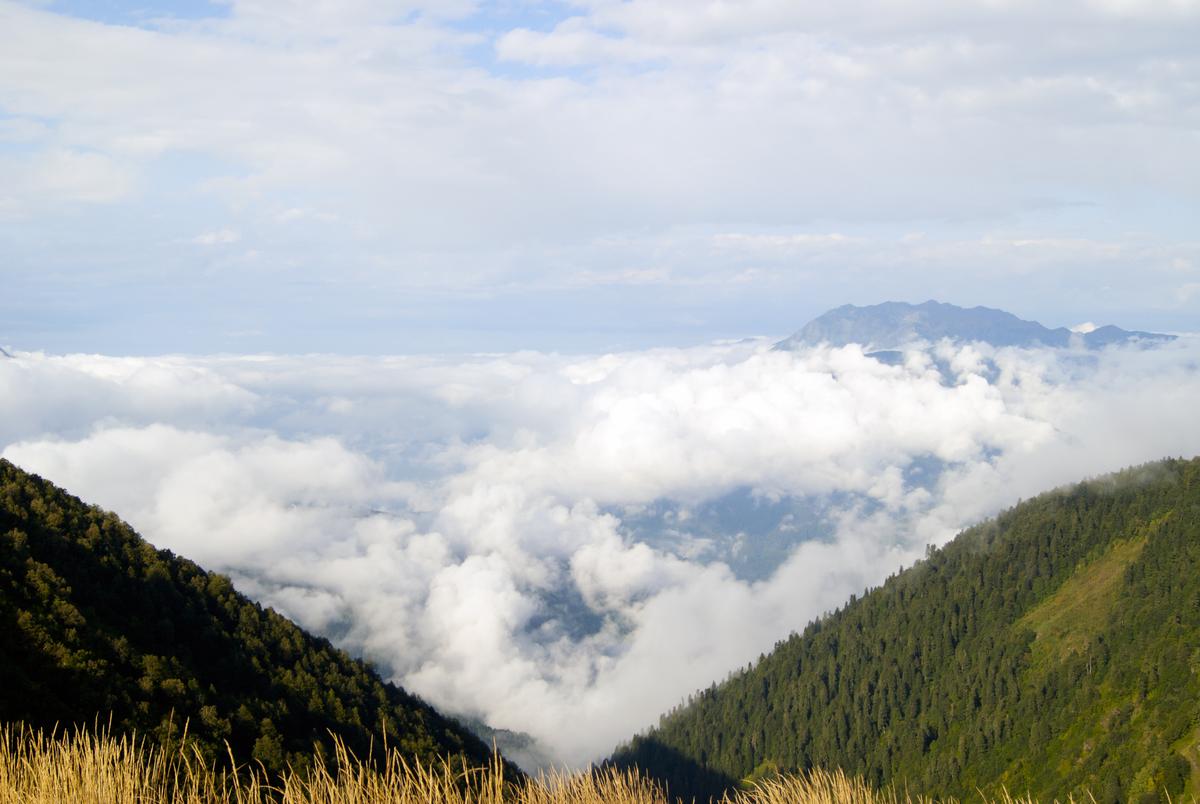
0,337 -> 1200,764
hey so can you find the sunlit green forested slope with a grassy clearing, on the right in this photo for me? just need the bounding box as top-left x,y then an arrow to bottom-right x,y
613,460 -> 1200,802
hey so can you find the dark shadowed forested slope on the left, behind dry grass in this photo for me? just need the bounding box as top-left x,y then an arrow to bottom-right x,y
0,460 -> 490,770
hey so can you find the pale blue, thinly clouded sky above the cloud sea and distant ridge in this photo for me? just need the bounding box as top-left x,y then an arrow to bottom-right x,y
0,0 -> 1200,354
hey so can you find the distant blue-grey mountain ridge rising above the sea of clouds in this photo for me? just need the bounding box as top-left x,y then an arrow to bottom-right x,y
775,300 -> 1175,352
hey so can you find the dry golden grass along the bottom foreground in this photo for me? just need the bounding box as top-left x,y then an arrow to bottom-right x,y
0,727 -> 1099,804
